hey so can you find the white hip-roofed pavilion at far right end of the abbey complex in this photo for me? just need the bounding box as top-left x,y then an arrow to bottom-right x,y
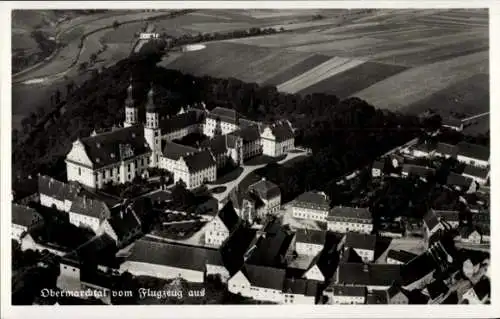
260,122 -> 295,157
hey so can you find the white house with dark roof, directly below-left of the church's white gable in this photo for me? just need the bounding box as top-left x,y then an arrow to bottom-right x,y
38,174 -> 78,212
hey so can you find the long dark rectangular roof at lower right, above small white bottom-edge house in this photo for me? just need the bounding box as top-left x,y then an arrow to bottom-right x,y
337,263 -> 401,286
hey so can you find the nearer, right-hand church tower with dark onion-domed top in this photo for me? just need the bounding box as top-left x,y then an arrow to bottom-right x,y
144,84 -> 161,167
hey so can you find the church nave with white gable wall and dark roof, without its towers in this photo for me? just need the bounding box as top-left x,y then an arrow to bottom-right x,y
66,125 -> 151,188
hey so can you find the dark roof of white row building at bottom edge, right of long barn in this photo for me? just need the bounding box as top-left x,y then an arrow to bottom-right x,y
242,264 -> 285,291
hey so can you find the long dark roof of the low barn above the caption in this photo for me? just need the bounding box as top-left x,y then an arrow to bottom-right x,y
127,238 -> 221,271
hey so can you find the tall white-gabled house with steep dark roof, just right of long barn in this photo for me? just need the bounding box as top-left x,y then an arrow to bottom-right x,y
205,201 -> 240,247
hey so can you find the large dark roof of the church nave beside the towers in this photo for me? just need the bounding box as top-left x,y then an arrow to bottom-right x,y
80,125 -> 151,169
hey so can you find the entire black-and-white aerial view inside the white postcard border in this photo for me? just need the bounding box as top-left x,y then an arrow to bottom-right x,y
6,8 -> 491,309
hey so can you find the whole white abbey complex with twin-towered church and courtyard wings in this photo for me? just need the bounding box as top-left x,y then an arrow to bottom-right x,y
66,81 -> 294,189
